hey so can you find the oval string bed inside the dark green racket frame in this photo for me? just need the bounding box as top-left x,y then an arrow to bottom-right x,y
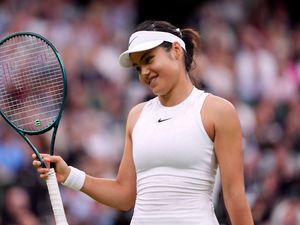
0,35 -> 64,131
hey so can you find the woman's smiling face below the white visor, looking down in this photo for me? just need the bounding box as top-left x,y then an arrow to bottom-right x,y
130,43 -> 183,96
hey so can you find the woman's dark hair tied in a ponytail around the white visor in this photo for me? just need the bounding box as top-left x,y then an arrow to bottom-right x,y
133,20 -> 201,82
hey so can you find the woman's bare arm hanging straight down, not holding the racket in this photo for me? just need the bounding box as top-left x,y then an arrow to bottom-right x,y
203,96 -> 254,225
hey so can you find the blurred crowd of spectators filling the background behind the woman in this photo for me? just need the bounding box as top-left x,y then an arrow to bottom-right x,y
0,0 -> 300,225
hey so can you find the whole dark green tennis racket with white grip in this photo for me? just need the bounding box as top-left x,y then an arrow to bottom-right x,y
0,32 -> 68,225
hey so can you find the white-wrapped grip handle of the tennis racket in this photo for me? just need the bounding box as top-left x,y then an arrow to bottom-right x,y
46,168 -> 68,225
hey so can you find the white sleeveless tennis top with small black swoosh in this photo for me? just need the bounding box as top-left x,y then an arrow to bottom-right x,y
131,87 -> 219,225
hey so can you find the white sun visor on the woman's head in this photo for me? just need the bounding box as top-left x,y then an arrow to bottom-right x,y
119,31 -> 185,67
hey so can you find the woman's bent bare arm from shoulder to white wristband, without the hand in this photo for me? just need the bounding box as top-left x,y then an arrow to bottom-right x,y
81,104 -> 147,210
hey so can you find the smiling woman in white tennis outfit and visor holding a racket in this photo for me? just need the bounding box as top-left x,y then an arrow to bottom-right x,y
33,21 -> 253,225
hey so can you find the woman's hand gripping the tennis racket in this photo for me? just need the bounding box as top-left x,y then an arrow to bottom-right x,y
32,154 -> 71,183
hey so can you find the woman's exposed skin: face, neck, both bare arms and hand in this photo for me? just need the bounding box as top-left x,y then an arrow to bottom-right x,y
33,42 -> 253,225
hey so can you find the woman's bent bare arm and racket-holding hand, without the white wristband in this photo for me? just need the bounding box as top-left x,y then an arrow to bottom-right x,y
33,104 -> 143,211
